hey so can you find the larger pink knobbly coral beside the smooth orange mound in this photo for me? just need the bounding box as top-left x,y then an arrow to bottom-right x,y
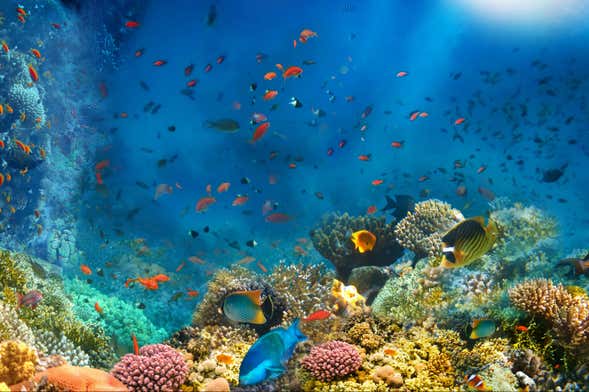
111,344 -> 188,392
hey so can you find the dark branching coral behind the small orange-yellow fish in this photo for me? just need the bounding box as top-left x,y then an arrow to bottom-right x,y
310,213 -> 403,282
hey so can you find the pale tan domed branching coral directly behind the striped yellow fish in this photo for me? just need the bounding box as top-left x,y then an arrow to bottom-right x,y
395,199 -> 464,259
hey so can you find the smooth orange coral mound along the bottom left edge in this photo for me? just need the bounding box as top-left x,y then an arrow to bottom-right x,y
10,365 -> 127,392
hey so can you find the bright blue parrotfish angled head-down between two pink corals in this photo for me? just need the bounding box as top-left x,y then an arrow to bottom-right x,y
239,319 -> 307,385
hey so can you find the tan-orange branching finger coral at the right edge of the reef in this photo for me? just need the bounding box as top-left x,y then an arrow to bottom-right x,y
509,279 -> 589,354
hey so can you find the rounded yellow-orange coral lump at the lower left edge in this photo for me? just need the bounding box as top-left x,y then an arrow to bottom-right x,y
0,340 -> 38,385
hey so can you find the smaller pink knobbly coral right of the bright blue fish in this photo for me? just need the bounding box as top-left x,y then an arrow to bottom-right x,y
302,340 -> 362,381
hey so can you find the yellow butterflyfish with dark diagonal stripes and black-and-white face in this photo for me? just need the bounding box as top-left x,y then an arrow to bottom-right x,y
441,216 -> 498,268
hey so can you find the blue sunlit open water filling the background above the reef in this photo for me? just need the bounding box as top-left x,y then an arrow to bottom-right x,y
0,0 -> 589,350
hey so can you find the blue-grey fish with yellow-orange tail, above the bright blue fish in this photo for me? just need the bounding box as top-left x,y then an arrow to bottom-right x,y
223,290 -> 267,325
